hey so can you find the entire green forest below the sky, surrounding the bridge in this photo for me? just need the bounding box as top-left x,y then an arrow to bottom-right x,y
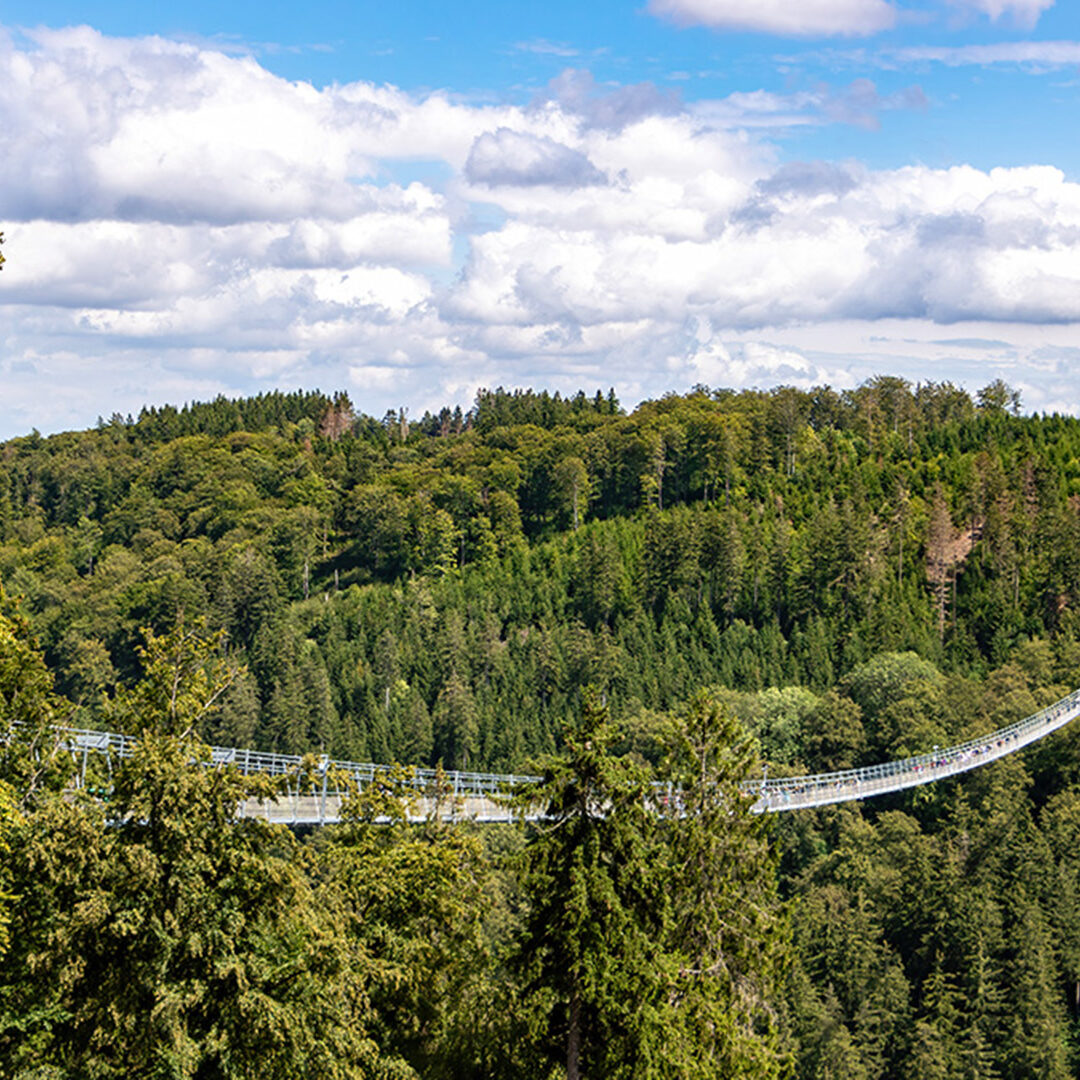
6,376 -> 1080,1080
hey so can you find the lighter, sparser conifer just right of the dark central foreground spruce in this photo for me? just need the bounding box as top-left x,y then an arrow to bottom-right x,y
662,693 -> 787,1078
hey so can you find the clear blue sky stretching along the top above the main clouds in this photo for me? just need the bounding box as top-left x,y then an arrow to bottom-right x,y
10,0 -> 1080,170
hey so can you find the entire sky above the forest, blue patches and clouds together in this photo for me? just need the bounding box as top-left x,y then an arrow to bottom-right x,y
0,0 -> 1080,437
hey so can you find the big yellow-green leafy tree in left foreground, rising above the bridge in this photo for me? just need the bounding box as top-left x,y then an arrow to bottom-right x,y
0,626 -> 379,1078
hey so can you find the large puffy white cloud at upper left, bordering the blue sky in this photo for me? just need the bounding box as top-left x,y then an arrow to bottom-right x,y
0,27 -> 540,225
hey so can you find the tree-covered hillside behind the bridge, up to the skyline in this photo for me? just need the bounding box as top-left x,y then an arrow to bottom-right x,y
0,377 -> 1080,768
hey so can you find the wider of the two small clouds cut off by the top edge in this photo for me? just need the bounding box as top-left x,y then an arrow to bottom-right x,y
649,0 -> 894,37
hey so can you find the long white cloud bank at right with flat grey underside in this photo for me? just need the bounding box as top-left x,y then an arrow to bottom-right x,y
455,164 -> 1080,327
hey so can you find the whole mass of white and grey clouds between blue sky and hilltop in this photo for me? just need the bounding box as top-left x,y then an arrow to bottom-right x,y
0,29 -> 1080,434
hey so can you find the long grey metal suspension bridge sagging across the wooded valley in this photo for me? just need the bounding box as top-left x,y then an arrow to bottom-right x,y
59,690 -> 1080,827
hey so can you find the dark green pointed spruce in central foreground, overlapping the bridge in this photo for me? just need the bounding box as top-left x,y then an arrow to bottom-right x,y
518,699 -> 671,1080
